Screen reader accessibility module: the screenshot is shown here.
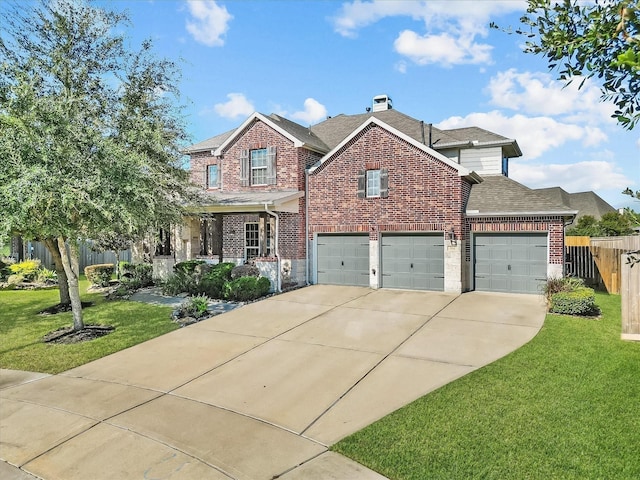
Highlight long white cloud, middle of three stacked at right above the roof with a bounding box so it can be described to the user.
[436,110,607,159]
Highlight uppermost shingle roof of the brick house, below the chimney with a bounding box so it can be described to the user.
[187,109,522,157]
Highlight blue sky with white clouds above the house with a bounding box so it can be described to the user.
[111,0,640,211]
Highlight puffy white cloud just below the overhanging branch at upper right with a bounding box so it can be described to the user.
[486,69,615,124]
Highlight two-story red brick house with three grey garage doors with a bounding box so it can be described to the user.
[157,96,575,292]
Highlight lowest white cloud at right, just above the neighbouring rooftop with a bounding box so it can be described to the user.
[509,160,629,193]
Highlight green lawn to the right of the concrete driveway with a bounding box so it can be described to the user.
[333,293,640,480]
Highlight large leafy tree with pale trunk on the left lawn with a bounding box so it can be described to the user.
[0,0,193,330]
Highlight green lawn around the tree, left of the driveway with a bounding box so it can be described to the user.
[0,280,178,373]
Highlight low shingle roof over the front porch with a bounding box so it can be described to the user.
[190,190,304,213]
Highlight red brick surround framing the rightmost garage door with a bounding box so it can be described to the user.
[465,216,564,265]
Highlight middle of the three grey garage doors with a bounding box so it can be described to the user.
[381,234,444,290]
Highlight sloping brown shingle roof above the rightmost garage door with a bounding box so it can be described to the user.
[466,175,577,217]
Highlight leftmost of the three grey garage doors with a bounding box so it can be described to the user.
[318,235,369,287]
